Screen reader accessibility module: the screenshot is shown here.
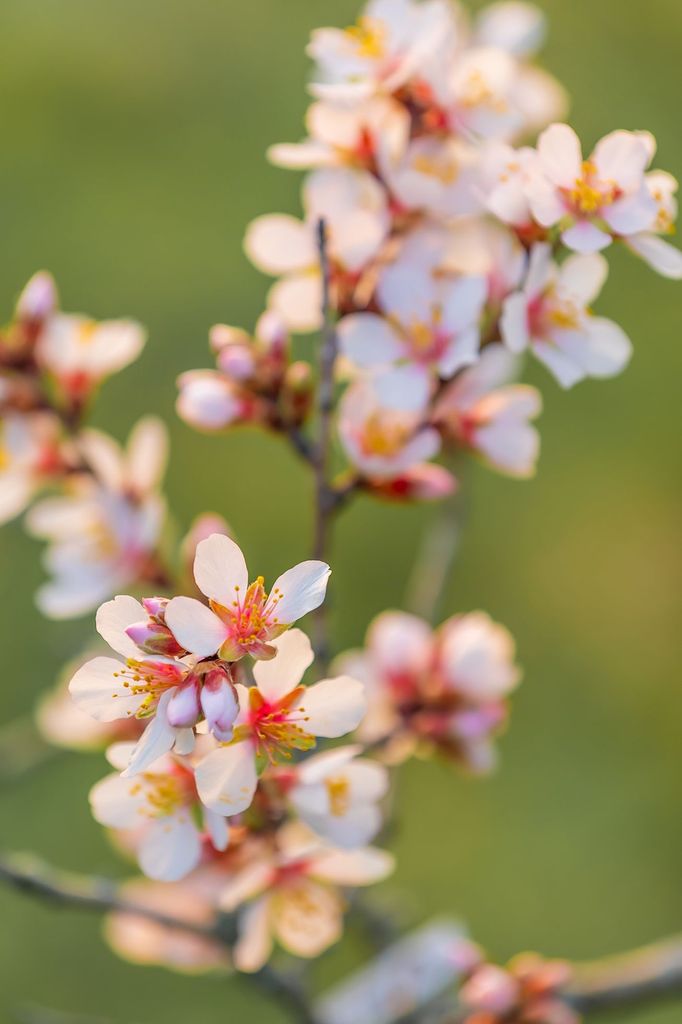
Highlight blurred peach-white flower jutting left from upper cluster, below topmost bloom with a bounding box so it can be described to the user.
[268,96,410,171]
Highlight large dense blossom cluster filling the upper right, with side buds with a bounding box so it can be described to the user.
[178,0,682,500]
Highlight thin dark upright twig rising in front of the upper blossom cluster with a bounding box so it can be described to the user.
[312,219,338,673]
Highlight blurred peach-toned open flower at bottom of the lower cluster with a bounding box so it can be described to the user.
[215,824,394,972]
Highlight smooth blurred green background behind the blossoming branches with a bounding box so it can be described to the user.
[0,0,682,1024]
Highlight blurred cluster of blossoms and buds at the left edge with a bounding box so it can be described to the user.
[0,272,173,618]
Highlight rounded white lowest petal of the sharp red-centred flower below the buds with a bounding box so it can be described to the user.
[195,740,258,817]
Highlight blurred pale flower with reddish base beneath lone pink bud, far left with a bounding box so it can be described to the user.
[36,313,146,402]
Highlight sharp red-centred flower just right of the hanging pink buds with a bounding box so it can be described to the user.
[191,630,366,816]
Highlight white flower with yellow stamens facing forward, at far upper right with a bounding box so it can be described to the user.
[527,124,656,254]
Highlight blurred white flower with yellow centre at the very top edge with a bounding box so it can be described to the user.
[307,0,456,103]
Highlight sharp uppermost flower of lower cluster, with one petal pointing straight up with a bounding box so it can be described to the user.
[161,534,331,662]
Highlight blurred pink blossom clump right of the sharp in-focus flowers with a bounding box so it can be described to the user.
[335,611,519,772]
